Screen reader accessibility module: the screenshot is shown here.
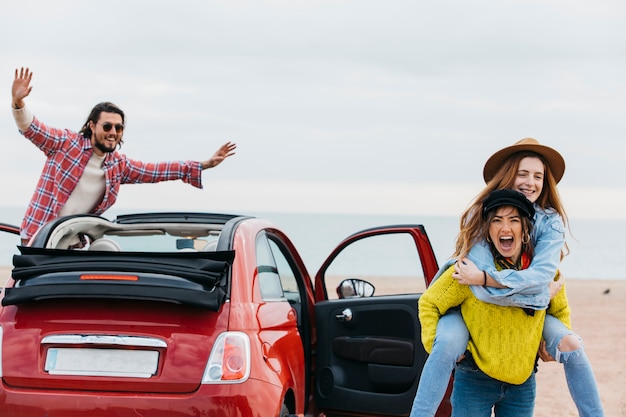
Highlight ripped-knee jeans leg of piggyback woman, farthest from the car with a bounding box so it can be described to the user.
[544,315,604,417]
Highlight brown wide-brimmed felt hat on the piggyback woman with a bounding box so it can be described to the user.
[483,138,565,183]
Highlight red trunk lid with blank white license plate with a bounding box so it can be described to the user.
[2,299,228,393]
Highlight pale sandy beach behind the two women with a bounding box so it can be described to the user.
[0,267,626,417]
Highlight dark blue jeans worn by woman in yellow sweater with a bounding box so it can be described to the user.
[452,361,536,417]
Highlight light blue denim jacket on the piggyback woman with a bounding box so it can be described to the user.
[435,206,565,310]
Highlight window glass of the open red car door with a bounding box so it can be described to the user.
[324,233,426,299]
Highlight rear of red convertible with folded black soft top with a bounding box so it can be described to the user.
[0,213,282,417]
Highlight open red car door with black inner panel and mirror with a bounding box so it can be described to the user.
[315,225,449,417]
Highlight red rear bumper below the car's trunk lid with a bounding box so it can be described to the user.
[0,379,283,417]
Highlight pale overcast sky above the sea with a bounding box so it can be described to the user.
[0,0,626,221]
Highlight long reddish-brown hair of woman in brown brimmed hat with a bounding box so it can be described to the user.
[453,151,569,258]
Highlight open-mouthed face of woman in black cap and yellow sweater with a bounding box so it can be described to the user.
[489,206,523,262]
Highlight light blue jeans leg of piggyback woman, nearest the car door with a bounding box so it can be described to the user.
[410,308,469,417]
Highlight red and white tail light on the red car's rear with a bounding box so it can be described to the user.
[202,332,250,384]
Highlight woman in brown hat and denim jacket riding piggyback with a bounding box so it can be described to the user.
[411,138,604,417]
